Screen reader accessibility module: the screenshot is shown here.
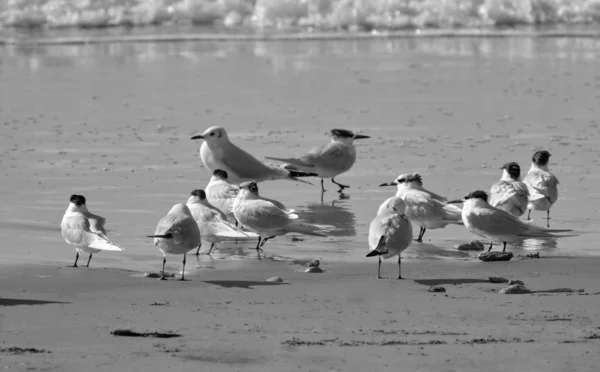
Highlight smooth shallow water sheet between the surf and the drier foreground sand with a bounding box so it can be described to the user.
[0,33,600,270]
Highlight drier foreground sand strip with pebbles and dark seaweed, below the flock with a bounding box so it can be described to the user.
[0,257,600,372]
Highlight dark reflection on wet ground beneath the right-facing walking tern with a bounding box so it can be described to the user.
[296,200,356,236]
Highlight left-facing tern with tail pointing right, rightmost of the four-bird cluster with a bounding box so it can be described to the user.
[233,182,333,259]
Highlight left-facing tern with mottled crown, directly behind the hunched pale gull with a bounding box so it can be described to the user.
[379,173,462,243]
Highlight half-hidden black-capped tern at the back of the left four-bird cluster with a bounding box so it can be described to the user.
[205,169,294,225]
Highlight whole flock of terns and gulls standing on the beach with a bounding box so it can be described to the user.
[61,126,572,280]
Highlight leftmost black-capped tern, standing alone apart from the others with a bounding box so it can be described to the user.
[60,194,124,267]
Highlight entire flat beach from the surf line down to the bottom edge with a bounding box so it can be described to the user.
[0,38,600,371]
